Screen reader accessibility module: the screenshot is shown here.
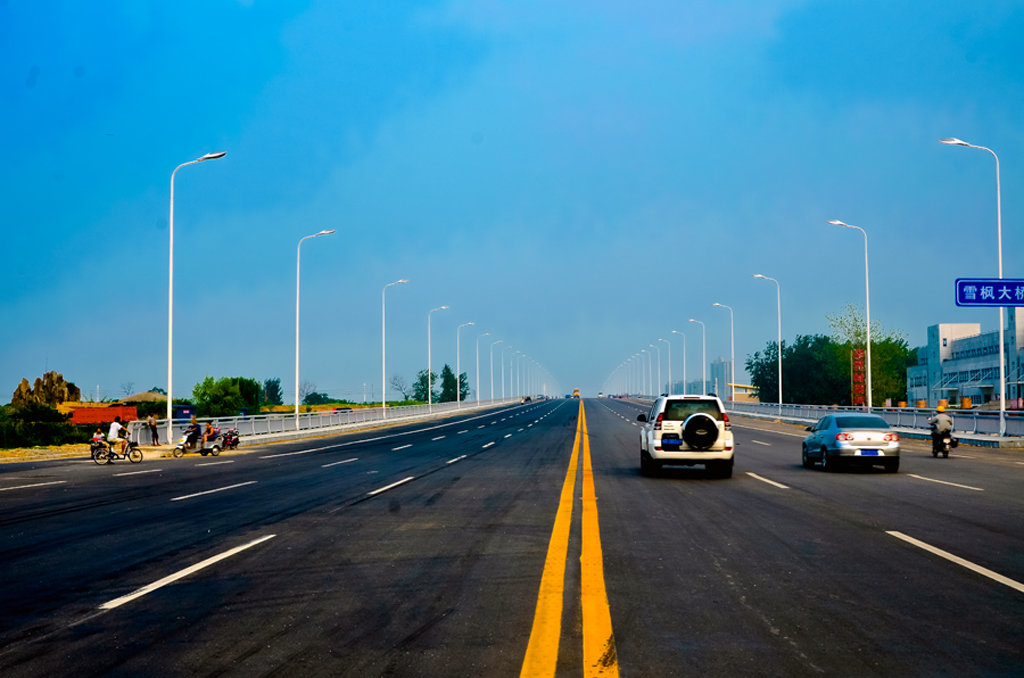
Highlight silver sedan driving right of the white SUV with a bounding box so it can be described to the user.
[803,412,899,473]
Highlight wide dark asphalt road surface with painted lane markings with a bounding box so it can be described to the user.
[0,399,1024,677]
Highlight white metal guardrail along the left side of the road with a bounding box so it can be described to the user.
[128,397,519,444]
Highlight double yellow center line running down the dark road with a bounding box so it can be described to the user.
[519,399,618,678]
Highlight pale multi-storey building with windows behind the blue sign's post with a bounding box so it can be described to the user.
[906,307,1024,408]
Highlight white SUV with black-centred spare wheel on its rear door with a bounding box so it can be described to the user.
[637,395,733,478]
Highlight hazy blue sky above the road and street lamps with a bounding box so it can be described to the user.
[0,0,1024,401]
